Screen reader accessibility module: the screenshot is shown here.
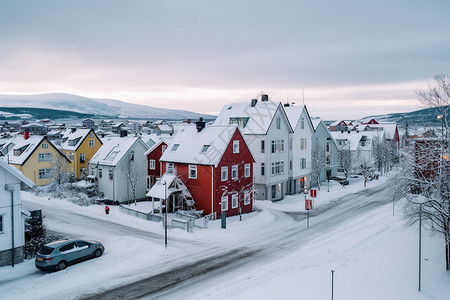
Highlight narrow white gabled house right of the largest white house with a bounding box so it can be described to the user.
[284,103,314,194]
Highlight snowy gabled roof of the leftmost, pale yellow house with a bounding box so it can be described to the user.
[3,135,70,165]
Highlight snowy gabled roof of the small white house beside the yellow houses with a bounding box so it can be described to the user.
[89,137,148,166]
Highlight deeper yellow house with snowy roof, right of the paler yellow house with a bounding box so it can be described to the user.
[61,128,103,179]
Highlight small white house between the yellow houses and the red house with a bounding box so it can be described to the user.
[88,137,149,202]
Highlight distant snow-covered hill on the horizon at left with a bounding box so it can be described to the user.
[0,93,215,120]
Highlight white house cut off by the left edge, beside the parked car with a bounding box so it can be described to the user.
[0,159,34,266]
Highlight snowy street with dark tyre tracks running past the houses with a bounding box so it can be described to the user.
[0,179,388,299]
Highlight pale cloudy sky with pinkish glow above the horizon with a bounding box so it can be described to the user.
[0,0,450,119]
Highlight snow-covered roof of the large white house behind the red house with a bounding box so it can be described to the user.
[214,101,281,134]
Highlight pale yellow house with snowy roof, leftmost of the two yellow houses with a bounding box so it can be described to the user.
[4,136,70,186]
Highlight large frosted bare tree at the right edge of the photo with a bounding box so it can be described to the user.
[394,75,450,270]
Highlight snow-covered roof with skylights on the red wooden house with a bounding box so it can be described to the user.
[161,124,239,166]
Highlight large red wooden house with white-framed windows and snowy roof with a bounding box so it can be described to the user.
[156,122,254,219]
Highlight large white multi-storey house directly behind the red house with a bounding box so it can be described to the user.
[214,94,292,200]
